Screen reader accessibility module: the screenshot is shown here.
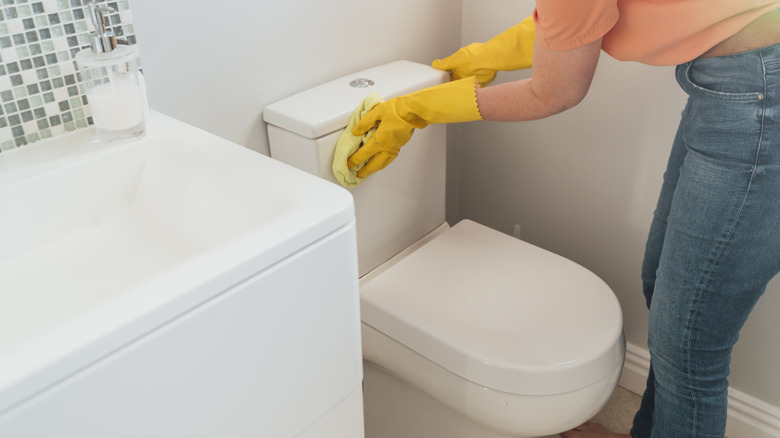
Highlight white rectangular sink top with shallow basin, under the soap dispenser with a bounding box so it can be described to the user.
[0,113,359,436]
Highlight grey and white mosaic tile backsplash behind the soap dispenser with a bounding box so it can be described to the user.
[0,0,135,153]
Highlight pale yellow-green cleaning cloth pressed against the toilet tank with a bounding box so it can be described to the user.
[332,93,384,188]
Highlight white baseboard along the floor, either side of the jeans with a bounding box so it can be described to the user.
[620,344,780,438]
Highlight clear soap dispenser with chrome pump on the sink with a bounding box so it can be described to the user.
[76,3,146,141]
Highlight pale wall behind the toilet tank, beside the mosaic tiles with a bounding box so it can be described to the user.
[130,0,461,154]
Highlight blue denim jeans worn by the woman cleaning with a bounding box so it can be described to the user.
[631,44,780,438]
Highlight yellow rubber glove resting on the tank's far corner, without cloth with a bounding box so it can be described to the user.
[432,16,536,87]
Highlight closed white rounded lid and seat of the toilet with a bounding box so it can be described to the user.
[360,221,625,395]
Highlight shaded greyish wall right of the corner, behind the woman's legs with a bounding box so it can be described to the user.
[458,0,780,406]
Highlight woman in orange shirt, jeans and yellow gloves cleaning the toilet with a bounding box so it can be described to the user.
[348,0,780,438]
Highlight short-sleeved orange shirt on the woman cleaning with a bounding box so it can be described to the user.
[534,0,780,65]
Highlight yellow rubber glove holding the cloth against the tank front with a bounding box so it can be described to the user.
[347,77,482,178]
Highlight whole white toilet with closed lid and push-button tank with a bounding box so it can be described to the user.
[264,61,625,438]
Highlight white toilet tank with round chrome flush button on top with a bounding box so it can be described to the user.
[263,61,449,276]
